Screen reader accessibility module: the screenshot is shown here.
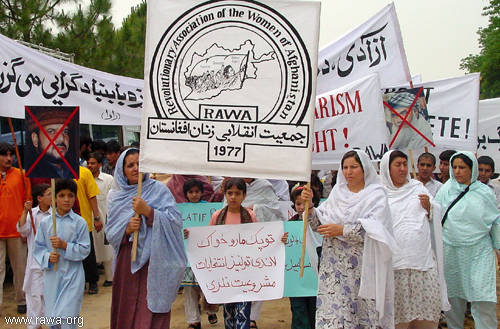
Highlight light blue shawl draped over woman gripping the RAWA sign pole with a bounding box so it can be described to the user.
[106,148,186,313]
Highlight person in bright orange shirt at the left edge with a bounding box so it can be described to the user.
[0,142,31,314]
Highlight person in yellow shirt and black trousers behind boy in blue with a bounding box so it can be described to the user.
[75,166,103,295]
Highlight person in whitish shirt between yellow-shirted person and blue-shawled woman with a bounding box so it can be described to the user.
[87,152,113,287]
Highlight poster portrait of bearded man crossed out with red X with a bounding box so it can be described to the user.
[26,108,79,178]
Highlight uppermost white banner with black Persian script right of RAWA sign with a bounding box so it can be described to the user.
[317,3,411,94]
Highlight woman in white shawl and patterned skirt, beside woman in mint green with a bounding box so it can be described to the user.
[380,150,449,329]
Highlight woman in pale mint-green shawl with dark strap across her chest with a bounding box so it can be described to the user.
[435,152,500,329]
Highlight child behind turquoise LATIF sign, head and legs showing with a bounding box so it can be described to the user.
[182,178,218,329]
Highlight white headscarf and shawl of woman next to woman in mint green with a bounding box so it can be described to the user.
[380,150,450,311]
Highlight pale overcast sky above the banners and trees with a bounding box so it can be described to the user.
[111,0,488,82]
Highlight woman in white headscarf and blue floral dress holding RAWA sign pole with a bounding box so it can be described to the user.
[301,150,396,329]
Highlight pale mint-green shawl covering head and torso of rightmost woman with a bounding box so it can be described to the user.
[435,151,500,249]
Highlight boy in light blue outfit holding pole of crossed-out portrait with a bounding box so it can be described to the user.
[33,179,90,328]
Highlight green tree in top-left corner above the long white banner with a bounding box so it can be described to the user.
[0,0,80,44]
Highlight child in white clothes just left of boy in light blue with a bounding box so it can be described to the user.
[17,184,52,329]
